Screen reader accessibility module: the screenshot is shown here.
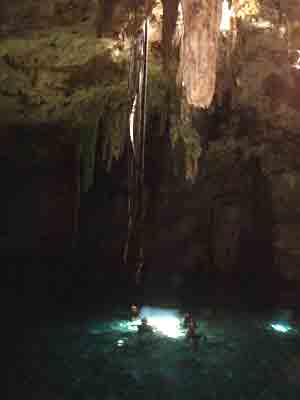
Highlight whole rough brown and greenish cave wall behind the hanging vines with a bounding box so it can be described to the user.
[0,2,300,304]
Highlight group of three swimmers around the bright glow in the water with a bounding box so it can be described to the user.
[131,304,199,351]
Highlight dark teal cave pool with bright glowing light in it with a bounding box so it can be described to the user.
[9,307,300,400]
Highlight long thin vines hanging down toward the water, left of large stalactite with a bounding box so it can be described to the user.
[123,10,148,290]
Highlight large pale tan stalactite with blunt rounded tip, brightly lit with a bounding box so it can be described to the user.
[182,0,222,108]
